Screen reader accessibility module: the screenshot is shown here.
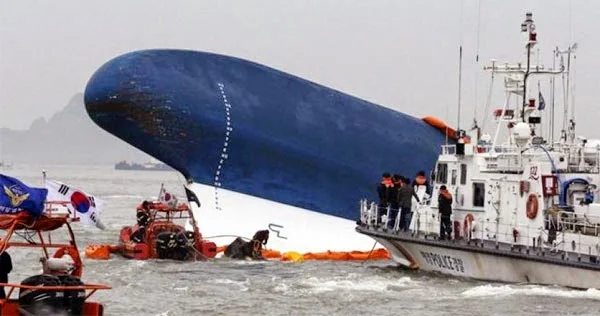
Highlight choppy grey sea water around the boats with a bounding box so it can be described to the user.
[0,165,600,316]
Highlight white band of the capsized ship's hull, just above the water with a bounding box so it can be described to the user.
[187,183,401,260]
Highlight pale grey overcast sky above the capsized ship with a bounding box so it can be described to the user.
[0,0,600,138]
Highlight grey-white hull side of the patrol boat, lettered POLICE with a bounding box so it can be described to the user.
[357,227,600,289]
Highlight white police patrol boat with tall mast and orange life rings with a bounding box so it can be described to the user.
[356,13,600,288]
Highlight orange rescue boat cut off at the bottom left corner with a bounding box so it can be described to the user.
[0,202,111,316]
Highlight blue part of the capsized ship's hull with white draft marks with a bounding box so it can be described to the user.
[85,50,444,219]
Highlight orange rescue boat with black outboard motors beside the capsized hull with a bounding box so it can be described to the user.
[116,201,217,261]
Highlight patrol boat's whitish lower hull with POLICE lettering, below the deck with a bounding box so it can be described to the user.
[372,236,600,289]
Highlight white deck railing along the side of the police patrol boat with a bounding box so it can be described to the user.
[360,200,600,263]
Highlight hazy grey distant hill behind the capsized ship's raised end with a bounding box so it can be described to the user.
[0,93,155,165]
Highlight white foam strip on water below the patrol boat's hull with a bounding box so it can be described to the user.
[462,284,600,300]
